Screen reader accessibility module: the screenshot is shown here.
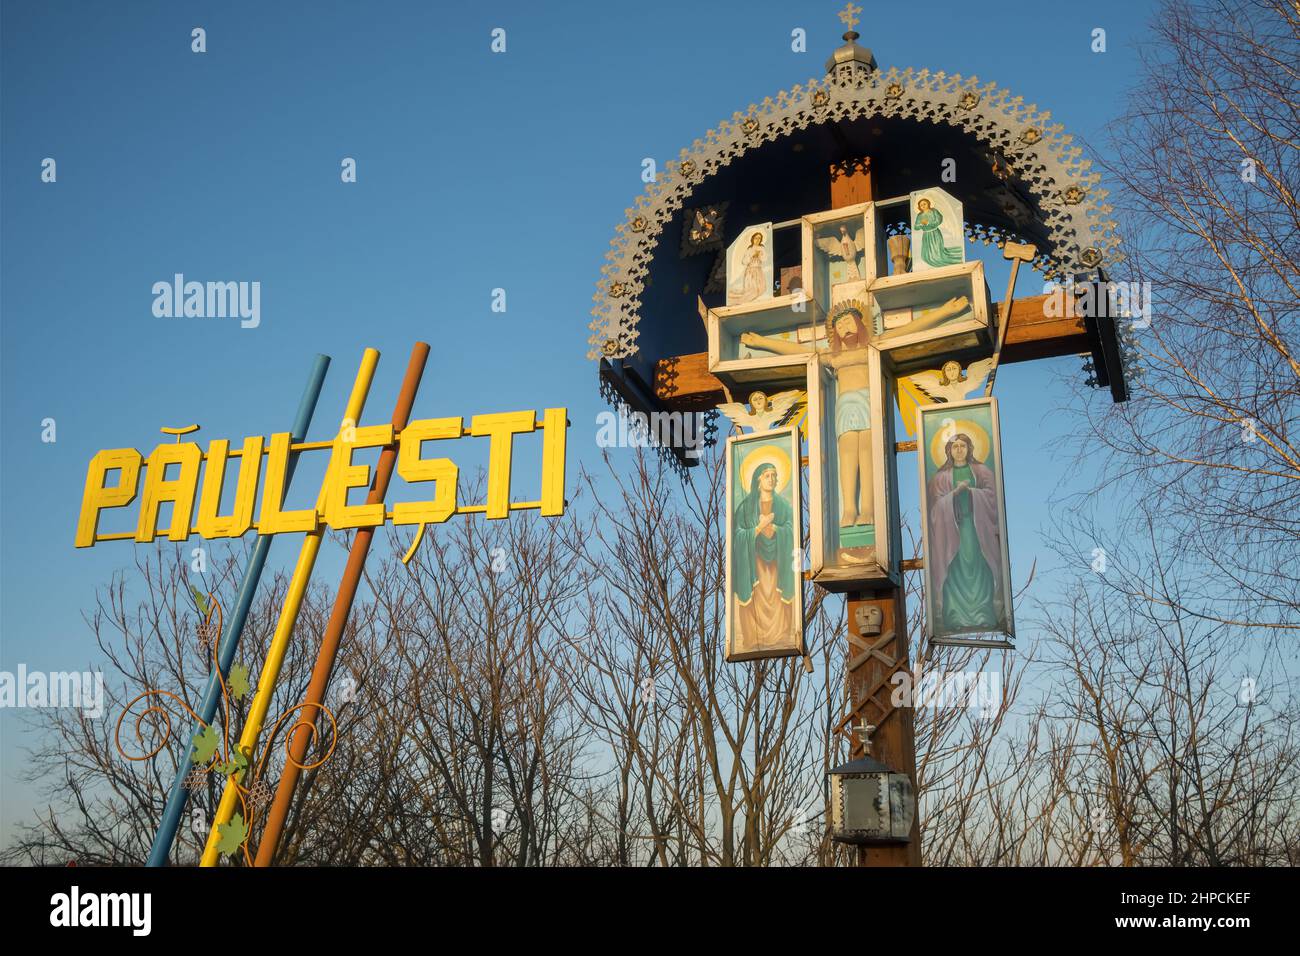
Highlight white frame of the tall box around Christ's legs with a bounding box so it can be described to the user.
[807,347,901,592]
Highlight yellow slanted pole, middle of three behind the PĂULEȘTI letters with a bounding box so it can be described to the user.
[199,349,380,866]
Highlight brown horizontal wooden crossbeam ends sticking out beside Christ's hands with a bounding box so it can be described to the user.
[654,295,1092,411]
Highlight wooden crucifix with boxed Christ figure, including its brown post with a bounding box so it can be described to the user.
[691,160,1089,864]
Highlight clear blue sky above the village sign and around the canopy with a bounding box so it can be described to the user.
[0,0,1152,842]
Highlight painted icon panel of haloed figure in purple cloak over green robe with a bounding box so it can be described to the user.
[917,398,1014,644]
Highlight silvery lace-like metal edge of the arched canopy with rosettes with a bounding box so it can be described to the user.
[588,60,1122,359]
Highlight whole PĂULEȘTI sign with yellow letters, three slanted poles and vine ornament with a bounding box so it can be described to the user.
[83,342,569,866]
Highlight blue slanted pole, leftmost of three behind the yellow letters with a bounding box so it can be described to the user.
[148,355,329,866]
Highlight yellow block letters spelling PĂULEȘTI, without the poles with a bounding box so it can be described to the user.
[77,408,568,558]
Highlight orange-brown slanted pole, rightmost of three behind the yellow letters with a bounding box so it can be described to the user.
[254,342,429,866]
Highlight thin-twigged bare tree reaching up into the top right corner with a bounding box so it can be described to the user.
[1079,0,1300,637]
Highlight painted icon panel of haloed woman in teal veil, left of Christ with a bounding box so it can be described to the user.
[727,427,803,661]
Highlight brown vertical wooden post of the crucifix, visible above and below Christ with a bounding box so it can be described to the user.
[831,156,920,866]
